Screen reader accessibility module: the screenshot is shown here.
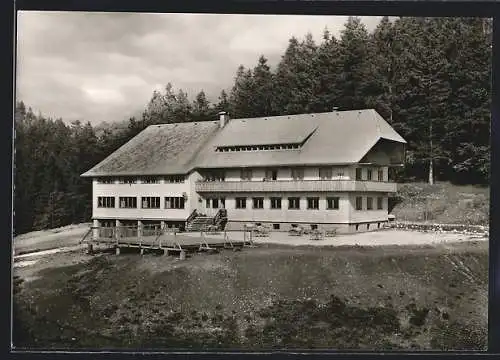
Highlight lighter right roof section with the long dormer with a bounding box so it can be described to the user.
[194,109,406,168]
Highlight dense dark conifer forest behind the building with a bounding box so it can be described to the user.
[14,17,492,234]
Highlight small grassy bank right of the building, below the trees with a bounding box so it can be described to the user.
[392,183,490,225]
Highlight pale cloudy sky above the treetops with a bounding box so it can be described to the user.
[16,11,380,124]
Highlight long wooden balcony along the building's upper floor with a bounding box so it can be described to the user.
[195,180,397,193]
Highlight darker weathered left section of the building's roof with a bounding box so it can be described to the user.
[82,121,219,177]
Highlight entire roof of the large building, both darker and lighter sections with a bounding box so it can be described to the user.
[82,109,406,176]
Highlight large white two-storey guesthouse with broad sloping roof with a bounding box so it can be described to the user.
[82,109,406,232]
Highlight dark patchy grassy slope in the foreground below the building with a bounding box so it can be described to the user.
[14,243,488,349]
